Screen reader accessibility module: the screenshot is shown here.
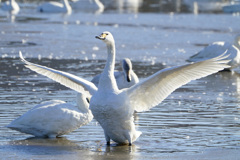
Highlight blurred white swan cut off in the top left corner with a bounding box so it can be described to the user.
[0,0,20,14]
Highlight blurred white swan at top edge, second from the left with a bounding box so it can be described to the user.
[37,0,72,13]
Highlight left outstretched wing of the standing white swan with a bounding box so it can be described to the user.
[19,51,97,95]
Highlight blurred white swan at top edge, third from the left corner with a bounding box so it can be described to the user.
[70,0,104,13]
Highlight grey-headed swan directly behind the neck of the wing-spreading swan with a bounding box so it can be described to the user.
[91,58,139,89]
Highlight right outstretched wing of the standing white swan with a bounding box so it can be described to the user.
[126,54,229,112]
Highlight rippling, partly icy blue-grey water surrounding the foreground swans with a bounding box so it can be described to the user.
[0,0,240,159]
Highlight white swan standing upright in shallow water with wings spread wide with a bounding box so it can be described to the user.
[17,32,229,145]
